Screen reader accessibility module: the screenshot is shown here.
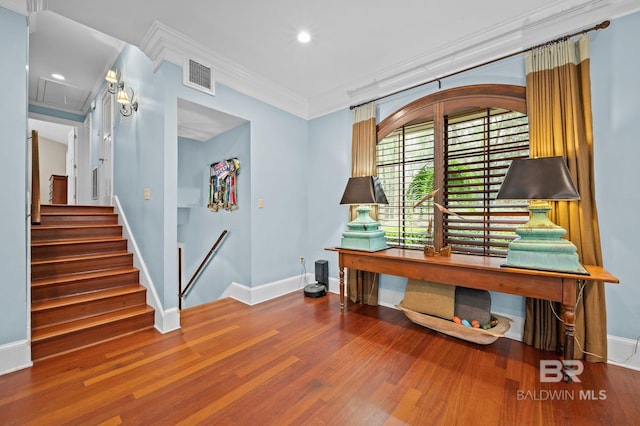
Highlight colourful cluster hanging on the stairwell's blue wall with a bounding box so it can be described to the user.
[207,158,240,212]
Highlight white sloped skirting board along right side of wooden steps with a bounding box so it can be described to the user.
[113,195,180,334]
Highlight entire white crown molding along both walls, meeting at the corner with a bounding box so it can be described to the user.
[15,0,640,119]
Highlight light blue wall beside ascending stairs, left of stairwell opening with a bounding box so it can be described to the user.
[108,45,172,309]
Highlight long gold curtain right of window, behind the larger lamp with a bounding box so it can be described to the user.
[524,35,607,362]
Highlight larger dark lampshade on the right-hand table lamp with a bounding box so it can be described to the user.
[496,157,580,200]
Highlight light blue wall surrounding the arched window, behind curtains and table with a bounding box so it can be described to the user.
[308,13,640,339]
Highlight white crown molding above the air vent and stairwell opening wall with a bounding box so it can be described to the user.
[139,21,309,119]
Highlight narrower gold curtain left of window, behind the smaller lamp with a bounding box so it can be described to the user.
[347,102,378,305]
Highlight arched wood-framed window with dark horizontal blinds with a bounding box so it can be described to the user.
[377,85,529,256]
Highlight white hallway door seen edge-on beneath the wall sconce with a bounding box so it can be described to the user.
[98,92,113,206]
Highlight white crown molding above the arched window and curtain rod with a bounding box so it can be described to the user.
[320,0,640,117]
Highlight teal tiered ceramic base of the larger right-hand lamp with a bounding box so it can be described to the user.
[502,202,589,275]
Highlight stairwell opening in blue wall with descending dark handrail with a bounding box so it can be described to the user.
[177,98,251,307]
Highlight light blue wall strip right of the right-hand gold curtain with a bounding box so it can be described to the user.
[591,13,640,339]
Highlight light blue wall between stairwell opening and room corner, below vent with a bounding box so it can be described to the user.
[169,71,309,287]
